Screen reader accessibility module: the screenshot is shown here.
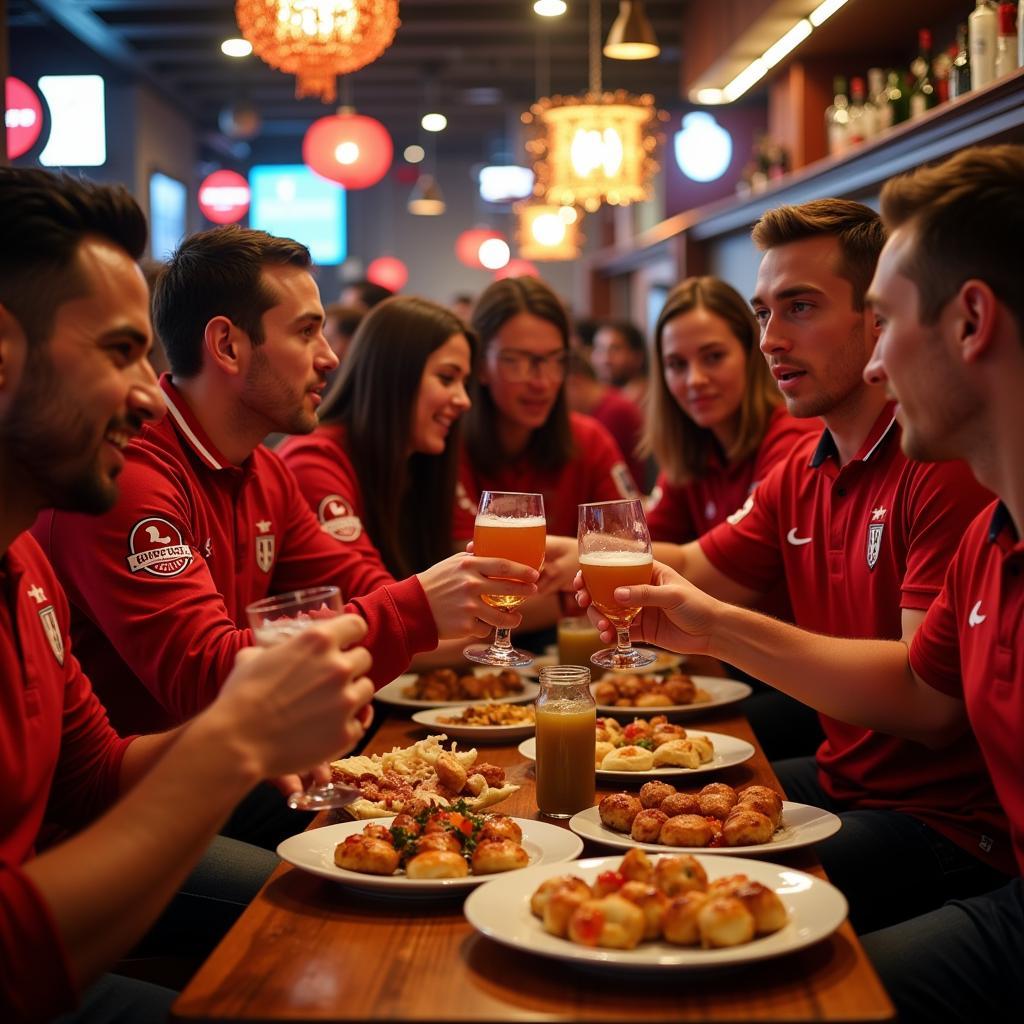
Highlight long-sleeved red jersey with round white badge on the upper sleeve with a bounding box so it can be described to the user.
[33,377,437,732]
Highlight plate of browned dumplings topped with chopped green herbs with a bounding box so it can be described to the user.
[278,805,583,898]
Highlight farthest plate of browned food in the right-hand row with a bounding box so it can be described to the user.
[590,671,752,718]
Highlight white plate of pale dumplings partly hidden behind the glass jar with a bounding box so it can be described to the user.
[518,719,754,782]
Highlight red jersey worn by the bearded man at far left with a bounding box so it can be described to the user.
[0,534,131,1020]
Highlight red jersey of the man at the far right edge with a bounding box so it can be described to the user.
[910,503,1024,872]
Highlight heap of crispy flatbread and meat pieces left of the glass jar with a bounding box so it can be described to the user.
[331,733,519,818]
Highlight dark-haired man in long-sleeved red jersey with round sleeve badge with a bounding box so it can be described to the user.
[34,225,538,849]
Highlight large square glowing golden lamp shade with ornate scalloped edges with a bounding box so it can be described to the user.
[522,90,668,212]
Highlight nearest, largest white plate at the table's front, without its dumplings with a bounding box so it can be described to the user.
[464,856,847,971]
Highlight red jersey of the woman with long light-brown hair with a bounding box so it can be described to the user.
[647,406,821,544]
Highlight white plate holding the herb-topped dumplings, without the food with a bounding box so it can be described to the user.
[278,816,583,898]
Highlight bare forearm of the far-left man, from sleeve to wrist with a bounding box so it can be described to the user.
[24,716,261,985]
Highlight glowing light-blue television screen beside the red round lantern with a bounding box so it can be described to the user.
[249,164,348,265]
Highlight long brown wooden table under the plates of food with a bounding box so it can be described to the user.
[174,692,893,1022]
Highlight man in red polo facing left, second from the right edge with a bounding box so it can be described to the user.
[581,200,1014,931]
